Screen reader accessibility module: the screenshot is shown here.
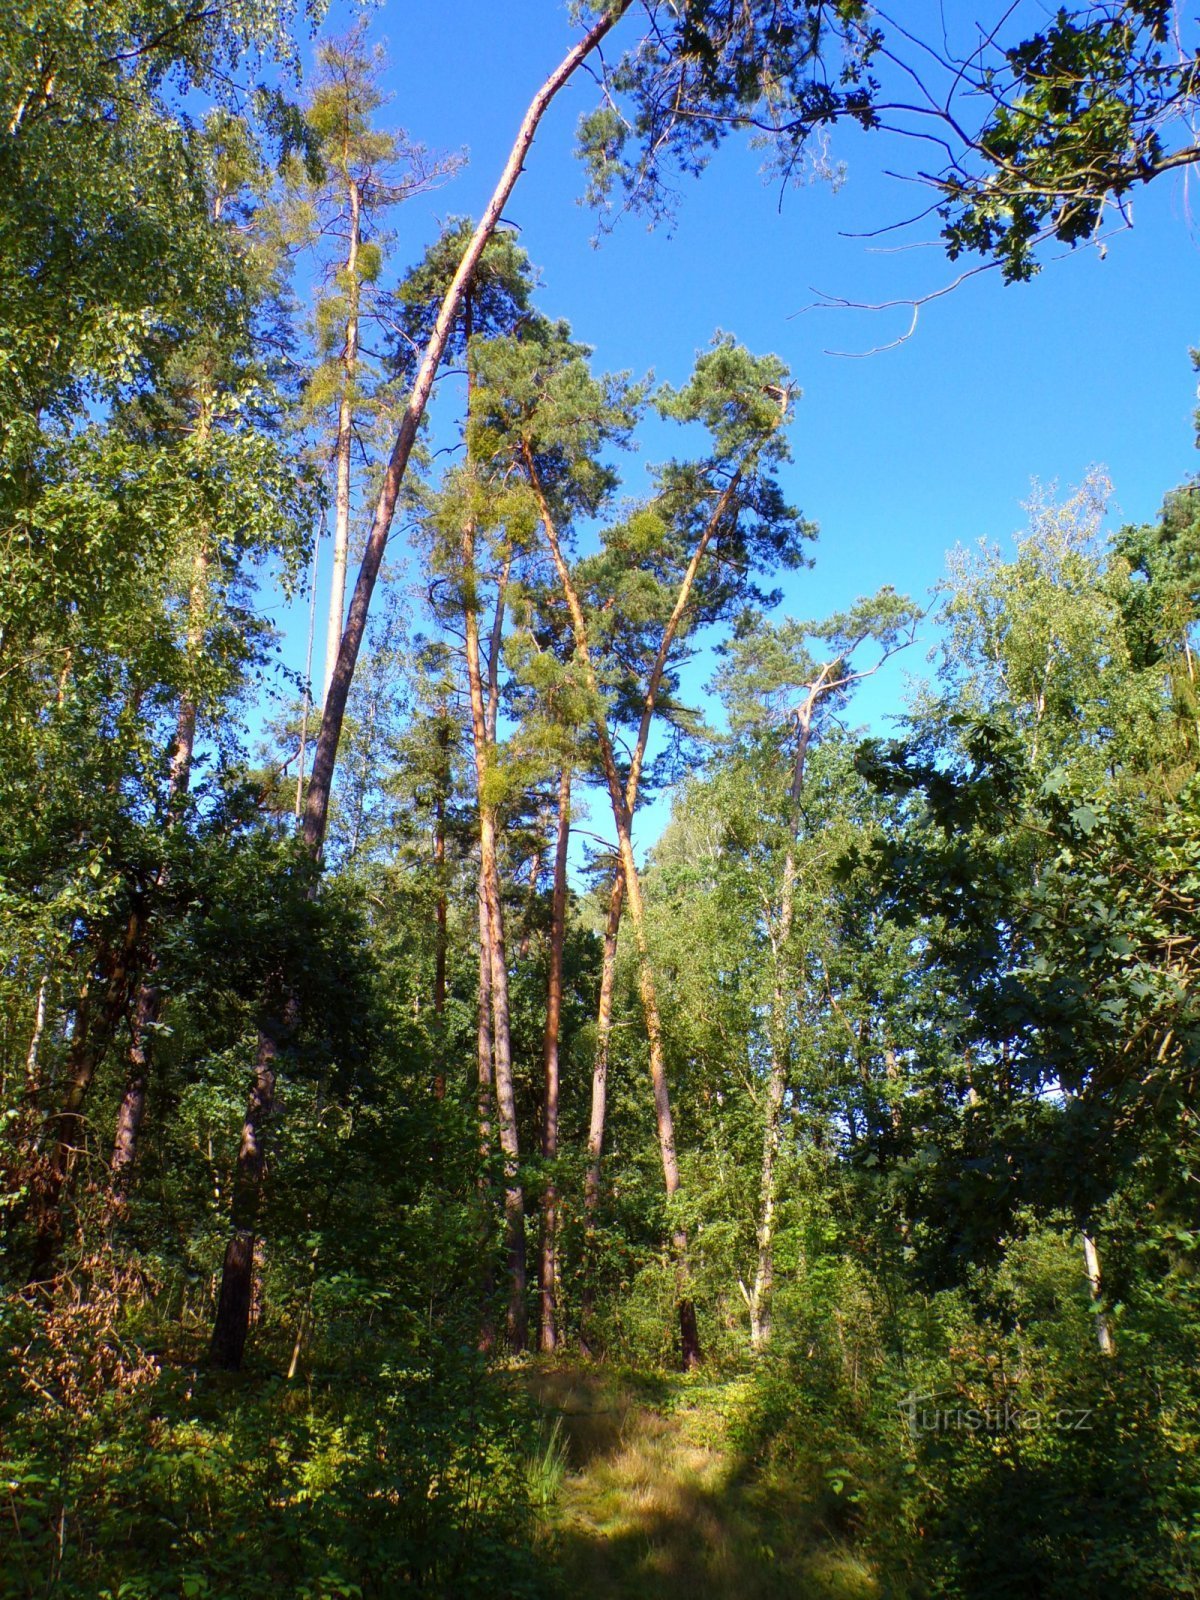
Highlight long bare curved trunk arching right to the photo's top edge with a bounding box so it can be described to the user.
[304,0,632,854]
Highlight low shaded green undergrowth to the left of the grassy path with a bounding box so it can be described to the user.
[0,1349,555,1600]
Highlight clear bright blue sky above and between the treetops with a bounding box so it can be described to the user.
[267,0,1200,846]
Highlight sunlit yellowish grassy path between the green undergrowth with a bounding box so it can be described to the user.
[525,1366,880,1600]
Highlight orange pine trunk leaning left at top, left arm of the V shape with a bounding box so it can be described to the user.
[526,458,701,1370]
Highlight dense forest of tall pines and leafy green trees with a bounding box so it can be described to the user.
[0,0,1200,1600]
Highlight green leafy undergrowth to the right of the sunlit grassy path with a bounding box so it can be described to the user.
[734,1234,1197,1597]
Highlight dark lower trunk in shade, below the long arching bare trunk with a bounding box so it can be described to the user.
[208,995,298,1373]
